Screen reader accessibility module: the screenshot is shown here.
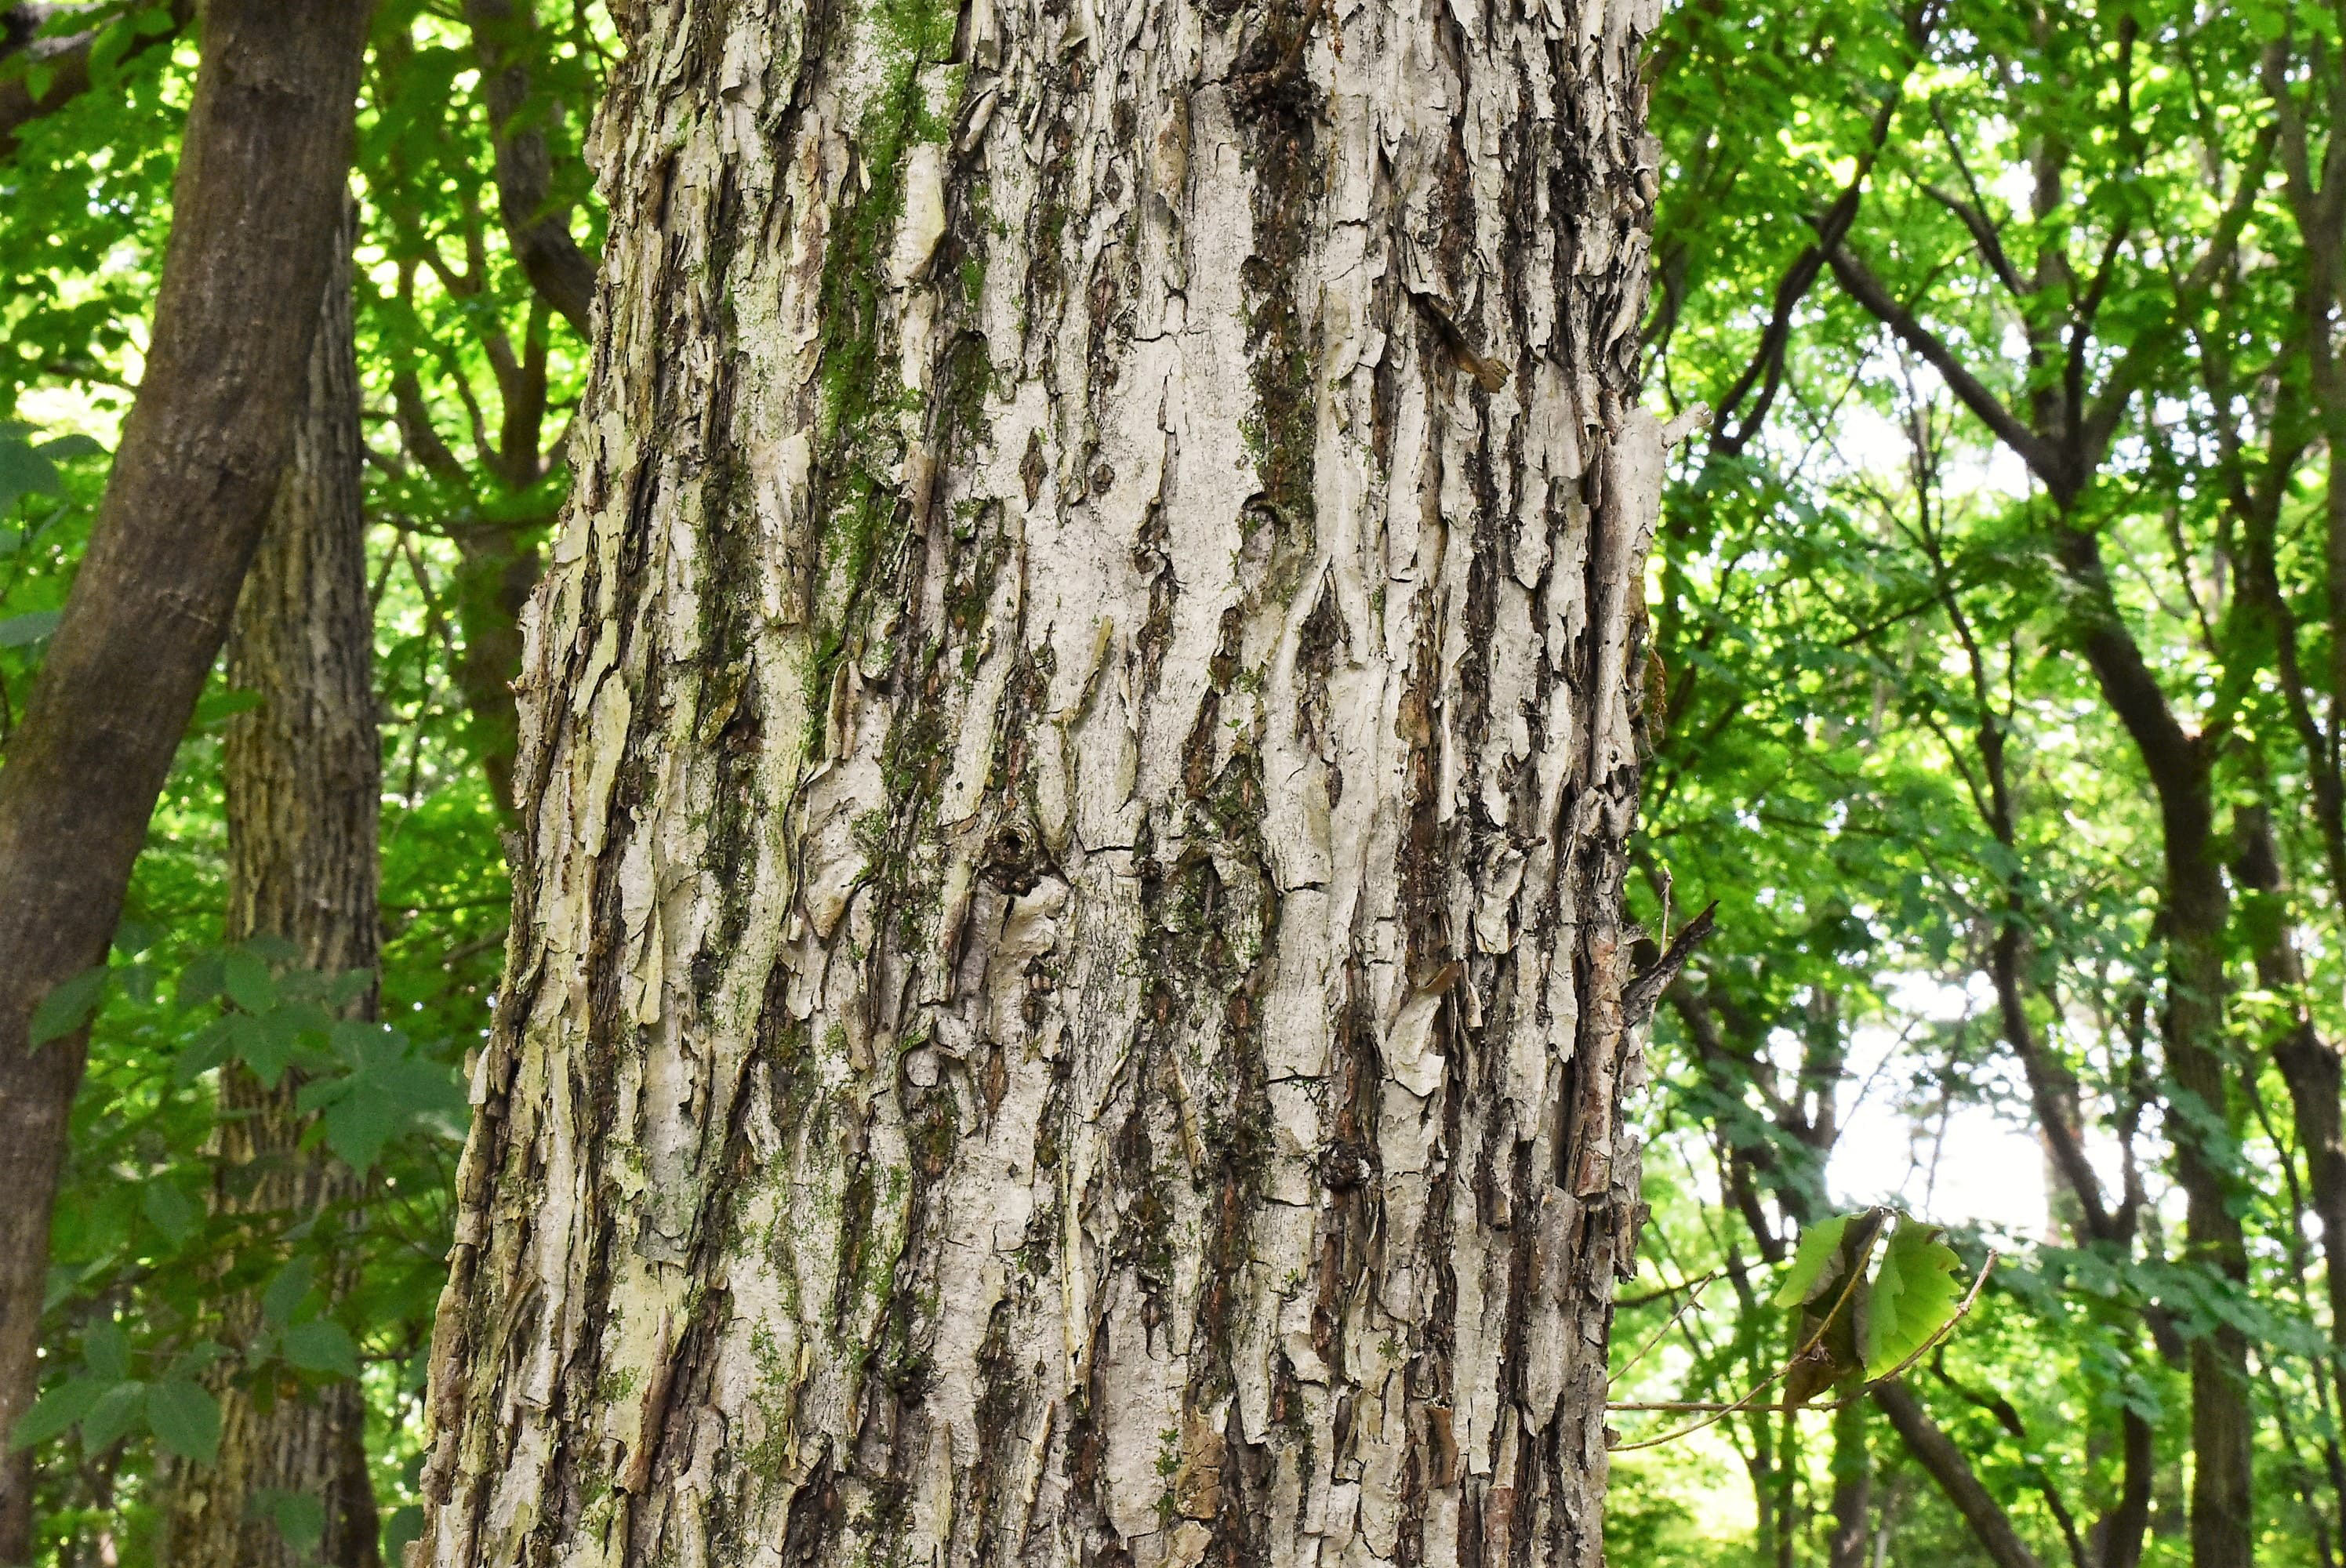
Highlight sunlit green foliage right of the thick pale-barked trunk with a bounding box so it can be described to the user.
[1614,0,2346,1563]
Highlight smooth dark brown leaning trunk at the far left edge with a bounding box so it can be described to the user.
[0,0,369,1563]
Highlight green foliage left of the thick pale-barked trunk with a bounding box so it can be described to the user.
[0,0,612,1566]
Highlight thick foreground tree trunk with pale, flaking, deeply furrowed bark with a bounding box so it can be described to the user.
[418,0,1663,1568]
